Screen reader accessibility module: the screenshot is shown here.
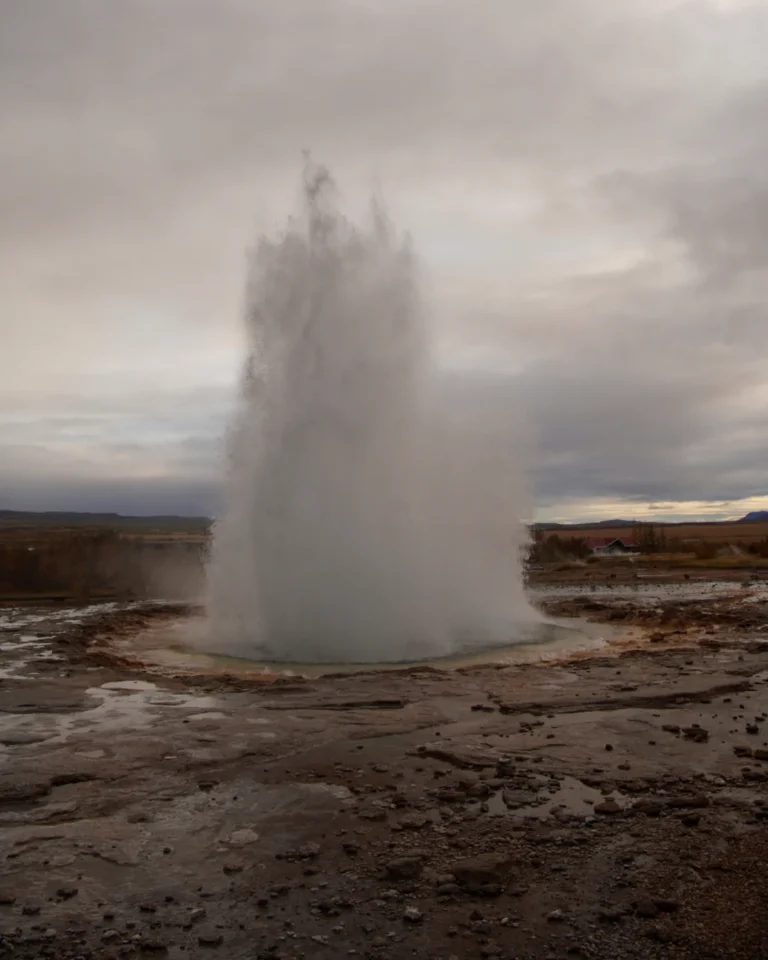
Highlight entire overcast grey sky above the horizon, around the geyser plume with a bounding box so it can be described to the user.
[0,0,768,519]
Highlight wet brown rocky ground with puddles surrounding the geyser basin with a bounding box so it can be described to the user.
[0,584,768,960]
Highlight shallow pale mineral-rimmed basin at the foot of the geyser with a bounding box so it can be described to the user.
[115,617,630,677]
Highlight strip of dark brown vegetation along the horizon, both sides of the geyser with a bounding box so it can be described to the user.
[0,515,768,602]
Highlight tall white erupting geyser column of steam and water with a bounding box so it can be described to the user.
[207,170,539,663]
